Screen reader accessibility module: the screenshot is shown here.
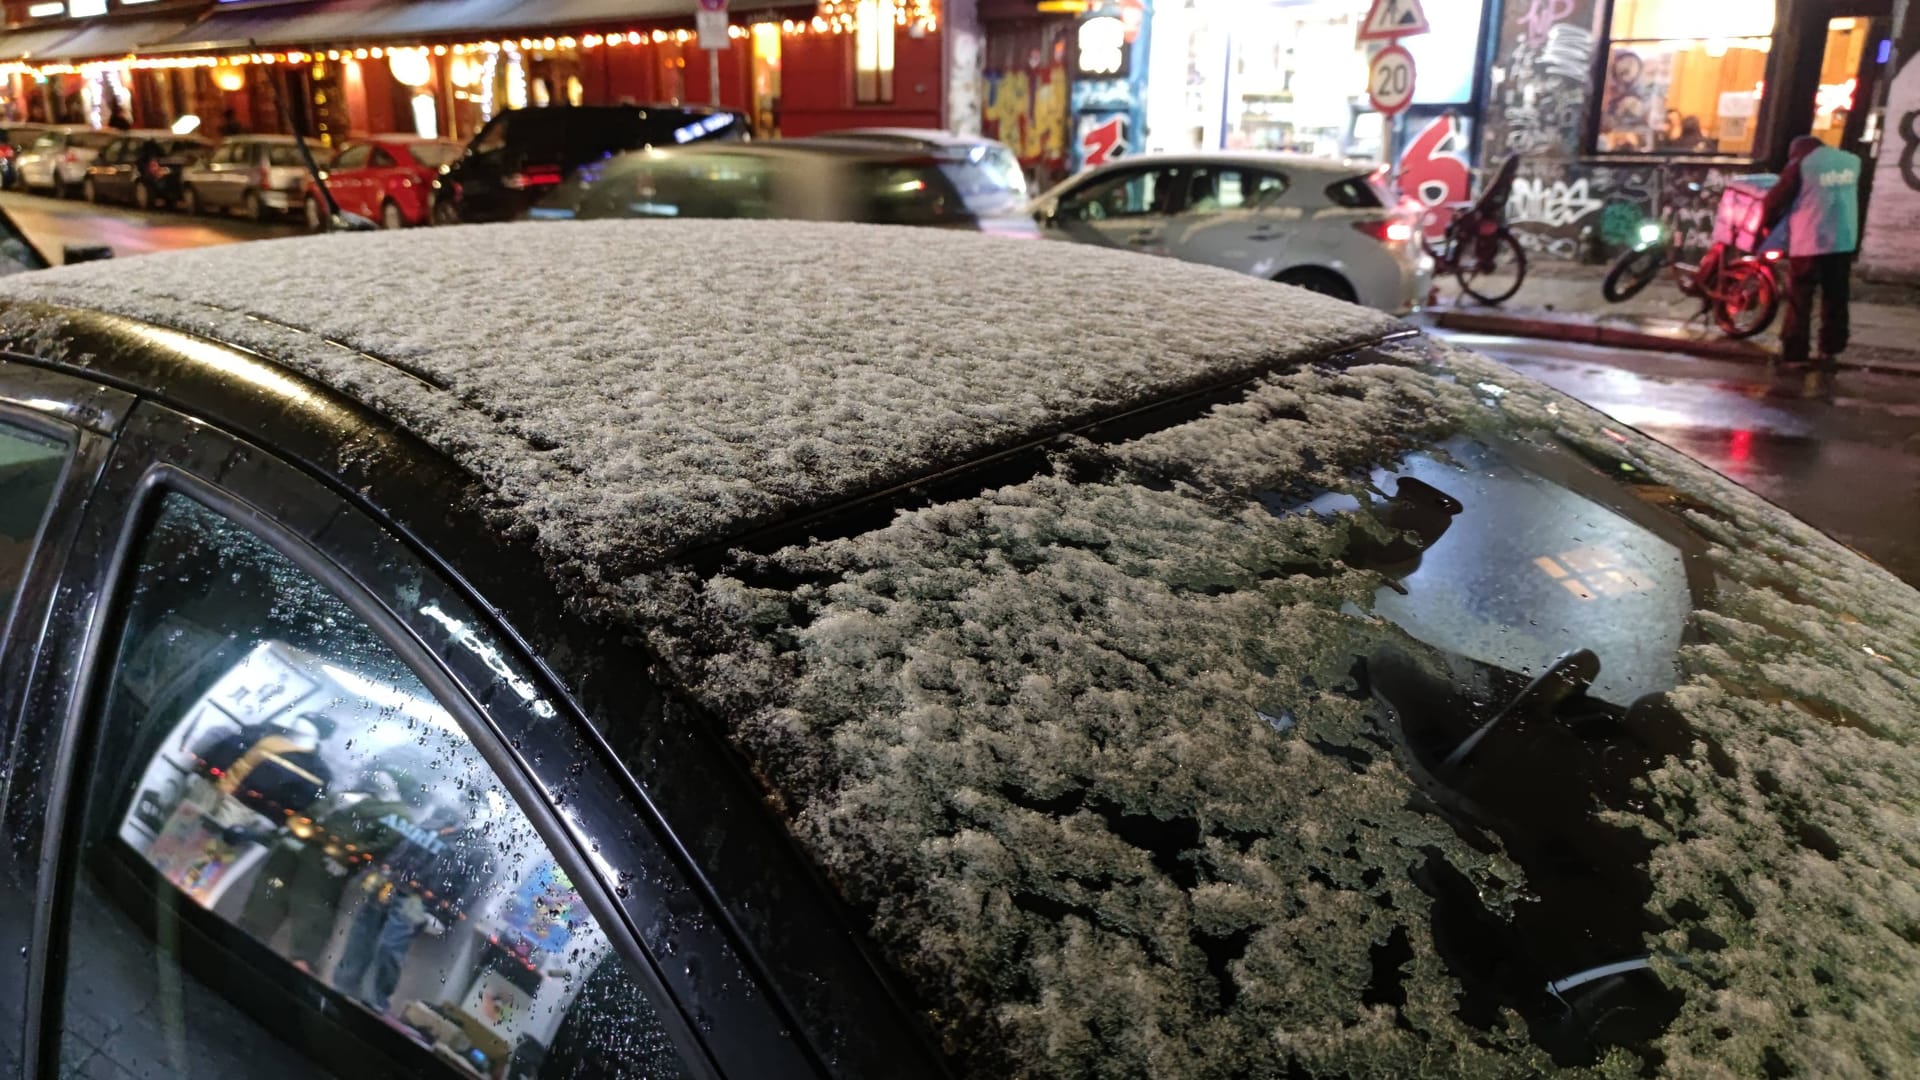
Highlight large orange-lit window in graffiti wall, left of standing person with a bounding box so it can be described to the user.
[1596,0,1774,156]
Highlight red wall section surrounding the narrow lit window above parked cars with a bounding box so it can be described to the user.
[780,29,943,136]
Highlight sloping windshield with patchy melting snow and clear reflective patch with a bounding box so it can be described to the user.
[662,338,1920,1076]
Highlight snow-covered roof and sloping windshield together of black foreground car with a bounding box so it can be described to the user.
[0,223,1920,1078]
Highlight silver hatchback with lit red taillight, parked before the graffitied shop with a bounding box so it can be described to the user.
[1031,152,1432,313]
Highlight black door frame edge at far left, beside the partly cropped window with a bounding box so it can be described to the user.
[0,352,134,1065]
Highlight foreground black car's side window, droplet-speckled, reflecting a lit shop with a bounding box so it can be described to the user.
[58,494,698,1080]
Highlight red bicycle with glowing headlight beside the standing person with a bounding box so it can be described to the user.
[1599,184,1788,340]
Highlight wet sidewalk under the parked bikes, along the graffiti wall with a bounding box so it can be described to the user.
[1415,261,1920,375]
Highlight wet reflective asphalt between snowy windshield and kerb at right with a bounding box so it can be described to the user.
[1446,334,1920,584]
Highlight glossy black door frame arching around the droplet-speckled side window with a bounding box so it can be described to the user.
[8,402,837,1076]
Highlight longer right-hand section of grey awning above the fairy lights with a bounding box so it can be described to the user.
[144,0,729,54]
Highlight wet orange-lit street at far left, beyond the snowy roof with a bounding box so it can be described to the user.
[0,184,300,263]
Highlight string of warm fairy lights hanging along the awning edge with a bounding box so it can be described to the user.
[0,0,939,77]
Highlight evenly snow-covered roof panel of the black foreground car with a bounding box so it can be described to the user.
[6,221,1402,565]
